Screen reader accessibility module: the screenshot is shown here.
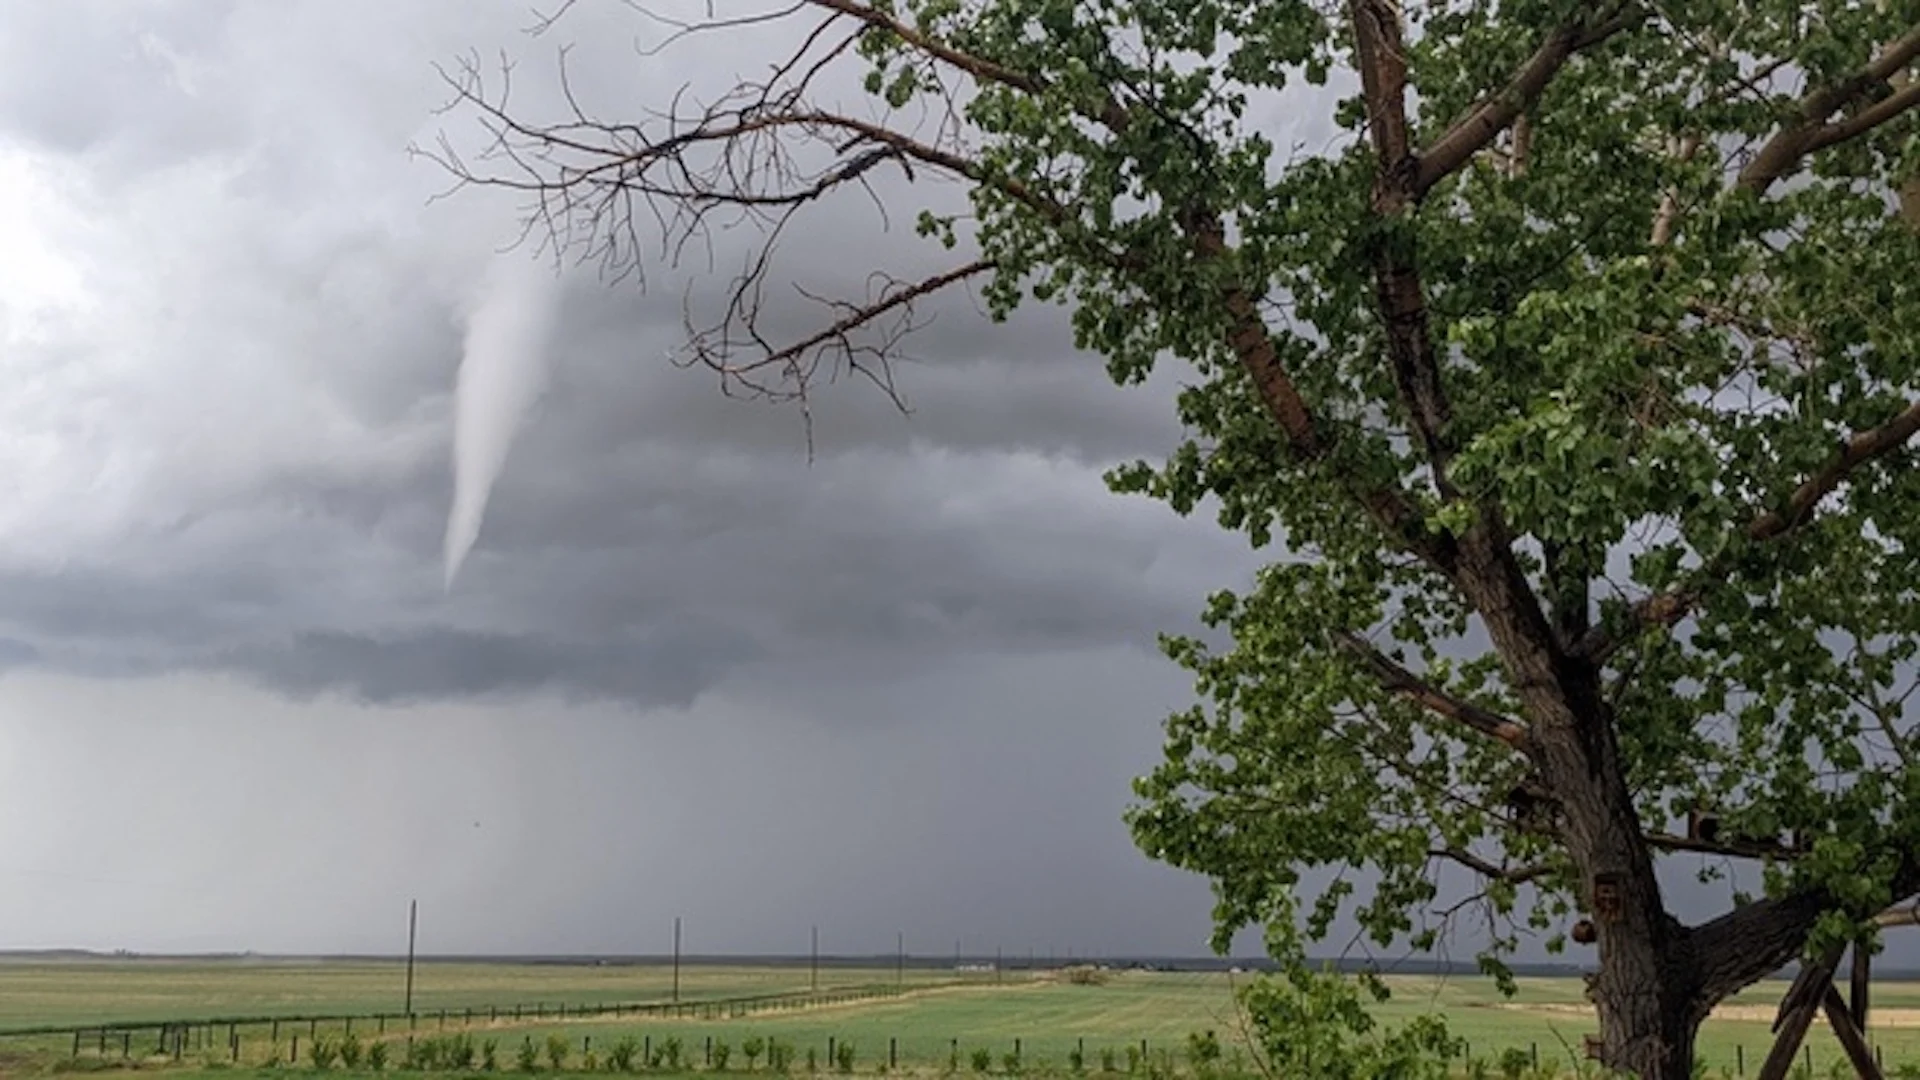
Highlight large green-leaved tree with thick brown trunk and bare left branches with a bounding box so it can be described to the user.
[444,0,1920,1078]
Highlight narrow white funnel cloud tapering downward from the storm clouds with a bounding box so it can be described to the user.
[444,256,559,590]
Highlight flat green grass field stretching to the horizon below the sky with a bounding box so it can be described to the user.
[0,961,1920,1080]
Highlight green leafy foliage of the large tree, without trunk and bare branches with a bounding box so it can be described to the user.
[866,0,1920,976]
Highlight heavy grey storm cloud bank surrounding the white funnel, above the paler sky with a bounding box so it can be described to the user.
[0,6,1246,705]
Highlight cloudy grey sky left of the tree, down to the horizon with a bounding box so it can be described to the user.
[0,0,1254,953]
